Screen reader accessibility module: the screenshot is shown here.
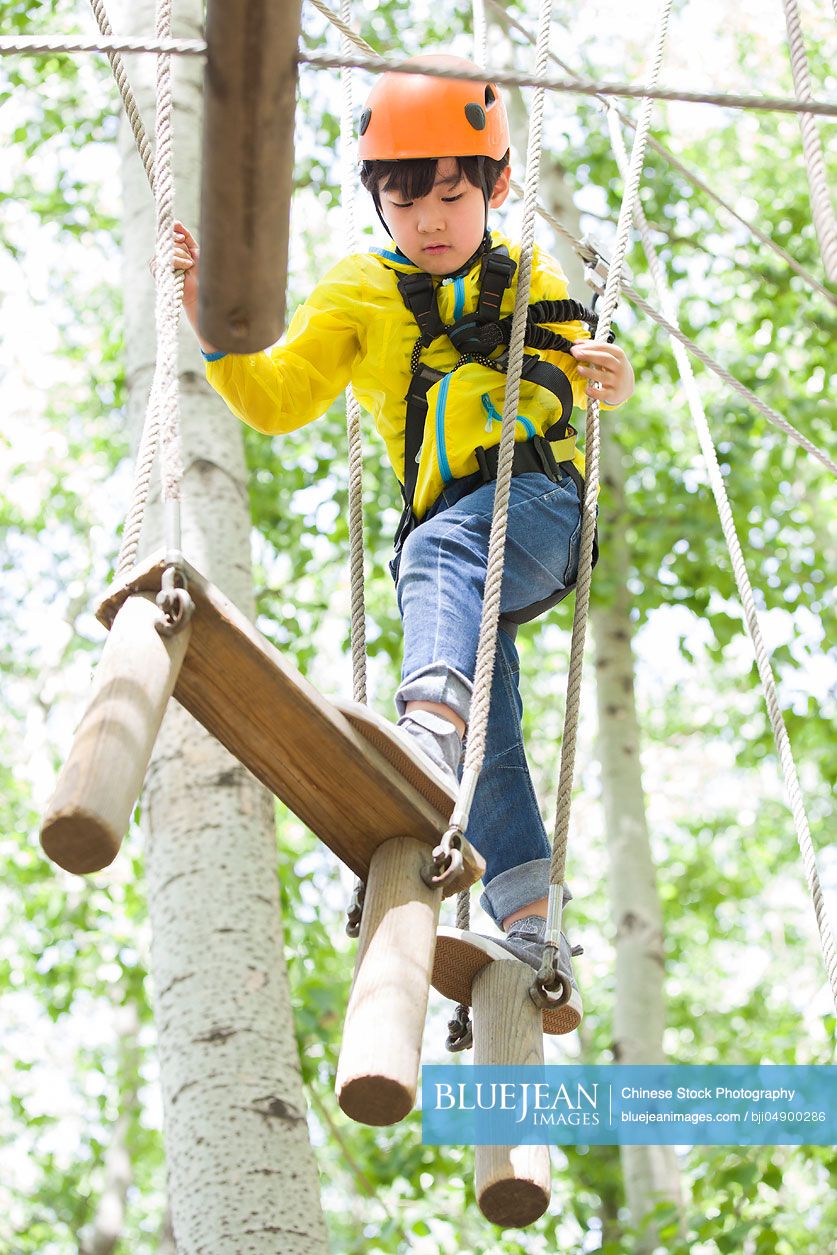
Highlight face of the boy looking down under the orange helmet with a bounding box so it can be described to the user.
[380,157,511,275]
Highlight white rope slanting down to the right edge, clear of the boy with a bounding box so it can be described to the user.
[609,110,837,1005]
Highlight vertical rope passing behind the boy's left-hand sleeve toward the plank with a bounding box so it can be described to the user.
[340,0,368,703]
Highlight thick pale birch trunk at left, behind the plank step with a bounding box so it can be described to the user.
[118,0,328,1255]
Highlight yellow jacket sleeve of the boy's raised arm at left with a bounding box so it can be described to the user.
[206,257,365,435]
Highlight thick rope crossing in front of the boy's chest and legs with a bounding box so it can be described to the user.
[450,0,552,929]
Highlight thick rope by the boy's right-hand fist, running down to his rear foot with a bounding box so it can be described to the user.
[550,0,673,893]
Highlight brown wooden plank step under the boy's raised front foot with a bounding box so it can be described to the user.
[97,555,484,896]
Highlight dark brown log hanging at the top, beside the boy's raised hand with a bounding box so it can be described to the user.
[198,0,300,353]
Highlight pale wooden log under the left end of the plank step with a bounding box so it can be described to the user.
[40,596,192,873]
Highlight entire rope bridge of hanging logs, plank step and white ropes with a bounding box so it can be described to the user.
[9,0,837,1225]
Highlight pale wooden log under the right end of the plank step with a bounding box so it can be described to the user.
[336,837,442,1124]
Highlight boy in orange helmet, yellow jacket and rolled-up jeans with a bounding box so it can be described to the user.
[176,55,634,1032]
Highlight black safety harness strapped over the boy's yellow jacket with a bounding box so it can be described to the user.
[390,245,602,625]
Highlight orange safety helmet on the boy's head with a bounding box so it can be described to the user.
[358,53,508,161]
